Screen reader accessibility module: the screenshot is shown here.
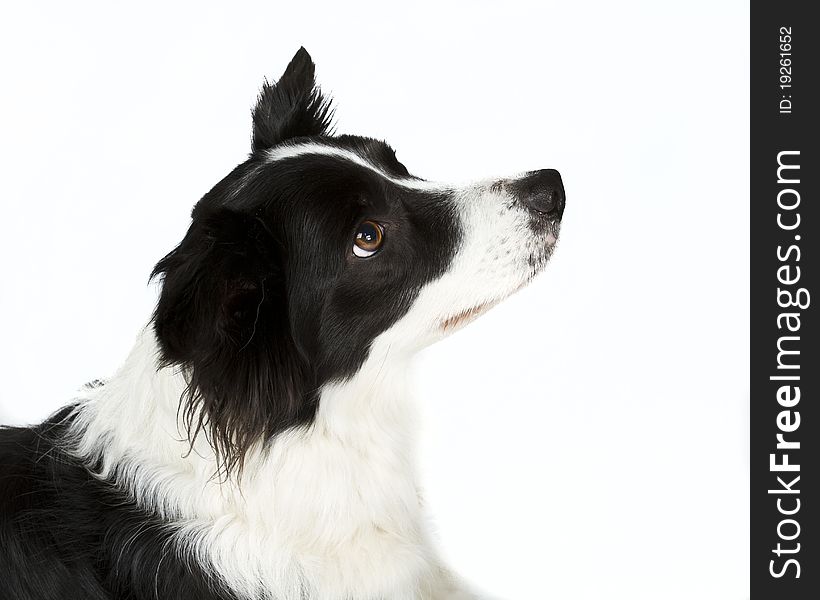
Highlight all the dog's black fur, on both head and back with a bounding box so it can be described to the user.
[0,49,461,600]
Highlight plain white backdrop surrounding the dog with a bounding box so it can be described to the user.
[0,0,749,600]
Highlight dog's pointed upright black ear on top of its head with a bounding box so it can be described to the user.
[252,48,332,152]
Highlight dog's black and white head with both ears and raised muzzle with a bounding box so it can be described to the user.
[154,49,564,465]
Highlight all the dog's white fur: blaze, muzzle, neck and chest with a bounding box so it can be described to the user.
[67,159,547,600]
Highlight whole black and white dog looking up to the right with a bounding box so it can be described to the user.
[0,49,564,600]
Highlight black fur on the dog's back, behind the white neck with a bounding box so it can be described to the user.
[0,408,235,600]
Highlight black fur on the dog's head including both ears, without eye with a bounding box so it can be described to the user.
[152,49,461,472]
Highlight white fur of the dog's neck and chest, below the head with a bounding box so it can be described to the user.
[67,328,468,600]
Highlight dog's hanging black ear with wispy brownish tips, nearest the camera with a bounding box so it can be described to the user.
[151,209,315,471]
